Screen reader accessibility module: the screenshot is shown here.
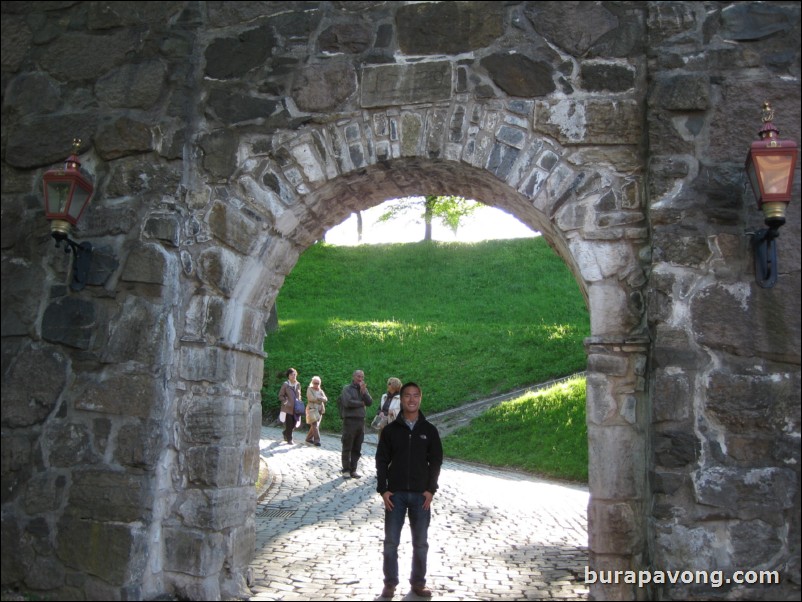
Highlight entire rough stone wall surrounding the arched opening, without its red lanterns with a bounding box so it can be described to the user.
[2,2,800,599]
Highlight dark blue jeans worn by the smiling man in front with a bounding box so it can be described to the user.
[384,491,432,587]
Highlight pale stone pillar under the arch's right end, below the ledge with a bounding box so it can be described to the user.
[585,337,649,600]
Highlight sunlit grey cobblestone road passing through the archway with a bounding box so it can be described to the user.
[251,427,588,600]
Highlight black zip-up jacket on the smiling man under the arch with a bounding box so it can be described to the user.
[376,412,443,494]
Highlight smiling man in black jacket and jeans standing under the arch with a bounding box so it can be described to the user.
[376,382,443,598]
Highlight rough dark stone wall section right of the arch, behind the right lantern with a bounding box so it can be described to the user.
[647,3,800,599]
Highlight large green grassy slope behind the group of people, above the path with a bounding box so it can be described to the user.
[262,237,589,480]
